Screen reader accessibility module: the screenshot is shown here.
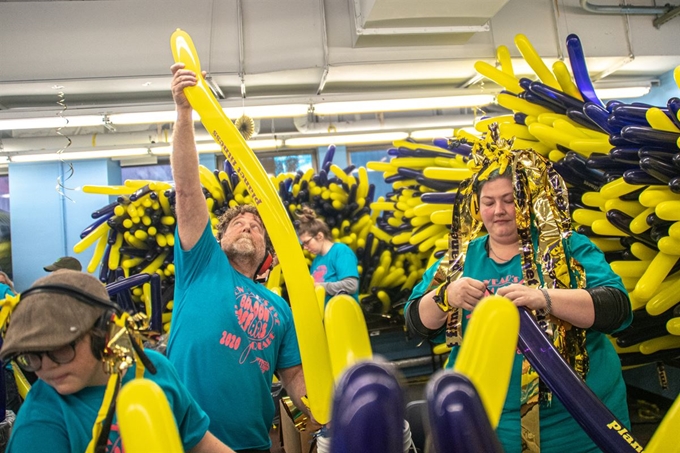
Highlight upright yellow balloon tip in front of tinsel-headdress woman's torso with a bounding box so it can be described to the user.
[453,295,519,428]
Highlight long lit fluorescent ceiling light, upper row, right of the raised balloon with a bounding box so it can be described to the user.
[314,94,494,115]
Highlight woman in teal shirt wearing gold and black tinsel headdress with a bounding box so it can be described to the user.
[405,125,632,453]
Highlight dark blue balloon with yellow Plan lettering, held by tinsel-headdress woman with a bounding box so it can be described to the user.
[518,308,642,453]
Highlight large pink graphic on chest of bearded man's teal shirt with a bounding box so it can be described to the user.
[234,286,281,372]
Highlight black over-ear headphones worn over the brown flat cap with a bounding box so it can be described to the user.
[21,283,122,360]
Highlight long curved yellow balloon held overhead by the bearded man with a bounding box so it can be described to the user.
[170,29,333,424]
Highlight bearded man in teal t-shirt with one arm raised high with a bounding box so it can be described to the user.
[167,63,307,452]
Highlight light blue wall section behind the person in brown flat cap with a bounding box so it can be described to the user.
[9,159,121,291]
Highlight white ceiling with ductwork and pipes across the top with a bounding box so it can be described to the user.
[0,0,680,152]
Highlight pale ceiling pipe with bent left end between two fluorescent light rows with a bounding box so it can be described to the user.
[293,115,475,134]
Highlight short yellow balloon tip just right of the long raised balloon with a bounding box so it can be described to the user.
[325,294,373,379]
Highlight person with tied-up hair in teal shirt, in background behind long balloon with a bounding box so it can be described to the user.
[295,206,359,303]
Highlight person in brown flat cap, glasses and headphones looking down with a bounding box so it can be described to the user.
[0,269,234,453]
